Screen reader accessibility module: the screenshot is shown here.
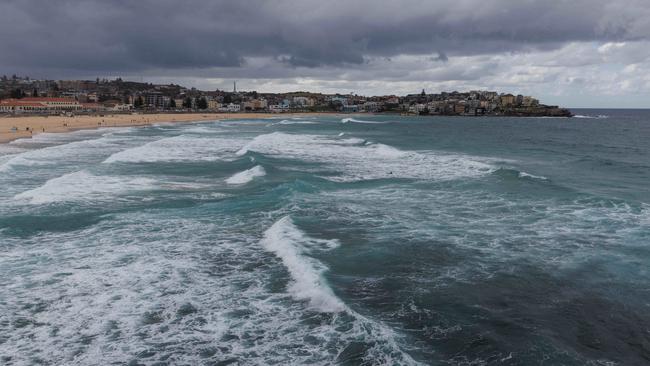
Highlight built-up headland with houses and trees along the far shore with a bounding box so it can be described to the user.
[0,76,571,117]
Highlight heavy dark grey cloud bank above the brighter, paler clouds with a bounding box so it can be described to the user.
[0,0,650,77]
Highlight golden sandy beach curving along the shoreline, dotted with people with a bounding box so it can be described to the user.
[0,113,318,143]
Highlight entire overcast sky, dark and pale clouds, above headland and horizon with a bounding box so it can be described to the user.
[0,0,650,108]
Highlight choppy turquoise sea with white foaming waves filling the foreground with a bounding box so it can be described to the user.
[0,110,650,365]
